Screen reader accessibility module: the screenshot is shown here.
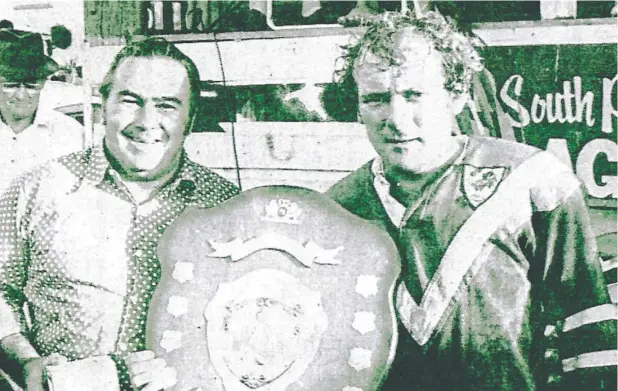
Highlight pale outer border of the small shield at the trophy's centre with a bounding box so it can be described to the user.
[203,268,328,391]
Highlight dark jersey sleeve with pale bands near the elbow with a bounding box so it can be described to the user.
[535,191,618,390]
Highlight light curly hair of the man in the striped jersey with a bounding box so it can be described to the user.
[335,10,483,94]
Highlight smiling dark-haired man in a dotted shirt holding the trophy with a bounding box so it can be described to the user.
[0,39,238,391]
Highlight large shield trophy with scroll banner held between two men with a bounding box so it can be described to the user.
[147,186,400,391]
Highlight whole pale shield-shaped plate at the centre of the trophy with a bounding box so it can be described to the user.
[205,269,328,391]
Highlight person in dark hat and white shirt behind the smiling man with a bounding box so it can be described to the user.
[0,29,84,192]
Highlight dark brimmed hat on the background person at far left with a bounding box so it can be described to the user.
[0,29,58,81]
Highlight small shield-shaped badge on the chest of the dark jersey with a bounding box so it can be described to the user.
[462,164,506,208]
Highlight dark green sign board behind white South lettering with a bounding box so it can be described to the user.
[484,44,618,201]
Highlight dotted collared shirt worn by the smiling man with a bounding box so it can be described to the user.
[0,147,238,388]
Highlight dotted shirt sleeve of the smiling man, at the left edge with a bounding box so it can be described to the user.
[0,177,28,339]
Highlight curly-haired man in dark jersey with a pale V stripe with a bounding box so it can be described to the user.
[328,11,617,391]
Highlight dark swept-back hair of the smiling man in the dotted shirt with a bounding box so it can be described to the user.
[99,37,201,131]
